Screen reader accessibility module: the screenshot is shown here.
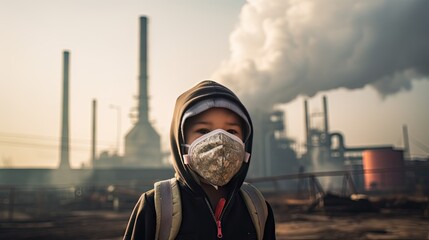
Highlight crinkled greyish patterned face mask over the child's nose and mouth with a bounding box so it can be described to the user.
[184,129,250,187]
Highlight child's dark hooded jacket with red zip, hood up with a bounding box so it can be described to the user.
[124,81,275,240]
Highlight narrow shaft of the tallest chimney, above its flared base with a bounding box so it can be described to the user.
[138,17,149,122]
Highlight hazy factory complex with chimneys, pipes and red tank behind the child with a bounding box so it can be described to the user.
[0,16,429,197]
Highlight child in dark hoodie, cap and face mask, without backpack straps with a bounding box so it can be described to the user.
[124,81,275,240]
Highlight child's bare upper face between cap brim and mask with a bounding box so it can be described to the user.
[185,108,243,144]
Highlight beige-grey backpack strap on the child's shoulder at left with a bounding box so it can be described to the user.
[154,178,182,240]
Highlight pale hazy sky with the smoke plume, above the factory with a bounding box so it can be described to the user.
[0,0,429,167]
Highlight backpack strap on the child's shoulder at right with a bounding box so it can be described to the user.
[240,182,268,240]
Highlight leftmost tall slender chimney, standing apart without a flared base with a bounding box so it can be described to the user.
[59,51,70,169]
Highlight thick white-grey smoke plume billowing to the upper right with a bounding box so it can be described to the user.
[212,0,429,108]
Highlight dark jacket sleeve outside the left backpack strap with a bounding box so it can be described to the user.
[123,190,156,240]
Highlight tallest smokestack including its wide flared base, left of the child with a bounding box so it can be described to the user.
[124,17,162,167]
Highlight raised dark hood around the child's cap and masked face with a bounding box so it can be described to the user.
[170,80,253,194]
